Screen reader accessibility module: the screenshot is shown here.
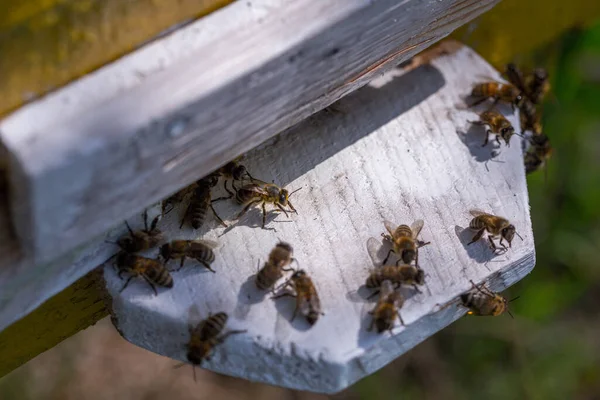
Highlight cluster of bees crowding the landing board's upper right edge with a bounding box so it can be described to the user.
[471,64,552,174]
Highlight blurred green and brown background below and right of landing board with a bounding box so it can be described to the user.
[0,11,600,400]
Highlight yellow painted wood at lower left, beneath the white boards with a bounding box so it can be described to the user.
[0,271,108,377]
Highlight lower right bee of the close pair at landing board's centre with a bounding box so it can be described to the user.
[273,270,323,325]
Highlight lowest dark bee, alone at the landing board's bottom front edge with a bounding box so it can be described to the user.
[186,312,246,366]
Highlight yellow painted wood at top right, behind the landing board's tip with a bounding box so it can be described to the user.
[452,0,600,70]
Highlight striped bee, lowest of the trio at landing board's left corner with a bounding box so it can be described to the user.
[116,251,173,295]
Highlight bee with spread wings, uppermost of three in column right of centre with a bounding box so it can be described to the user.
[381,219,430,266]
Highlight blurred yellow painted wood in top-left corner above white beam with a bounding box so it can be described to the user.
[0,0,232,116]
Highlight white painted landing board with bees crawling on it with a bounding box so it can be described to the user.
[104,44,535,393]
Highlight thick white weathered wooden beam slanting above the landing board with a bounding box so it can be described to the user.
[0,0,496,266]
